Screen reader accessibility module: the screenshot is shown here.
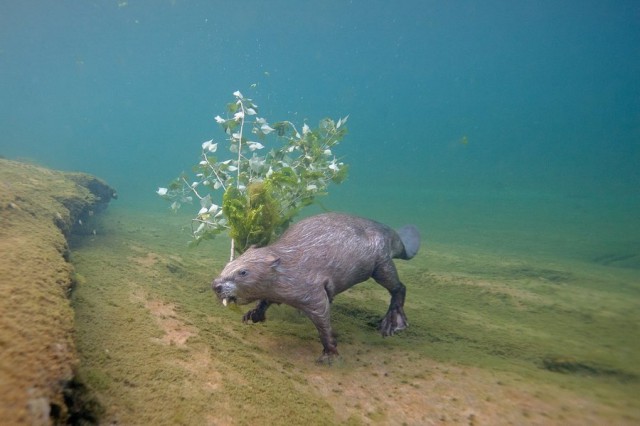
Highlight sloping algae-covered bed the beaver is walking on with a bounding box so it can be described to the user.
[73,211,640,424]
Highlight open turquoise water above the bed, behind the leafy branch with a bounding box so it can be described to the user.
[0,0,640,262]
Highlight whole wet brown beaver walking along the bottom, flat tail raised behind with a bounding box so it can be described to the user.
[211,213,420,363]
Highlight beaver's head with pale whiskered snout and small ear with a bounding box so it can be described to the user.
[211,248,280,306]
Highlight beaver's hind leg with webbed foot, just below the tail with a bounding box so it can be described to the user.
[371,259,409,337]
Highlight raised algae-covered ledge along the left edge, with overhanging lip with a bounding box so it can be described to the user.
[0,159,115,424]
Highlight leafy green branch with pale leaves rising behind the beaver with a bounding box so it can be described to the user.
[156,91,348,258]
